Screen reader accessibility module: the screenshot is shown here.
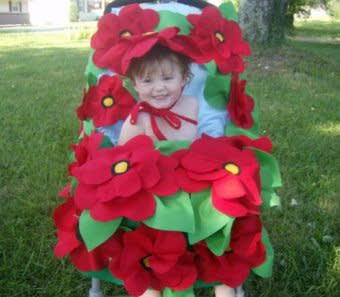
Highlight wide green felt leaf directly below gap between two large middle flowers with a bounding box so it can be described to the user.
[144,191,195,232]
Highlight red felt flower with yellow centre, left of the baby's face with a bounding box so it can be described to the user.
[77,75,135,127]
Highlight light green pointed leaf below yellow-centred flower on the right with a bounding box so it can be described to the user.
[188,189,234,244]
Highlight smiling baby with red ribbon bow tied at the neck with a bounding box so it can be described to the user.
[118,45,198,144]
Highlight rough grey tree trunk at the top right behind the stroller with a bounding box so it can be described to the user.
[239,0,289,43]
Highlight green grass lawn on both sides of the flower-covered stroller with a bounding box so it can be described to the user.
[0,19,340,297]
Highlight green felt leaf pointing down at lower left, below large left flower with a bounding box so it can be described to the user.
[79,210,122,251]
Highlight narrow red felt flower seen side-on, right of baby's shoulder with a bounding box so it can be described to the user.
[227,74,254,129]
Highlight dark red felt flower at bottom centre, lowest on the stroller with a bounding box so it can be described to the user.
[109,225,197,296]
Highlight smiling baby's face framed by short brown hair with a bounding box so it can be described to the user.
[134,61,185,108]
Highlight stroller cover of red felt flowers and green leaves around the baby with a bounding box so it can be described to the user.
[54,3,281,296]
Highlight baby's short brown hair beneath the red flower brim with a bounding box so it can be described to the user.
[126,45,192,81]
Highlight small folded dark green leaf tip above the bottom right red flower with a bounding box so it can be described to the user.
[206,218,234,256]
